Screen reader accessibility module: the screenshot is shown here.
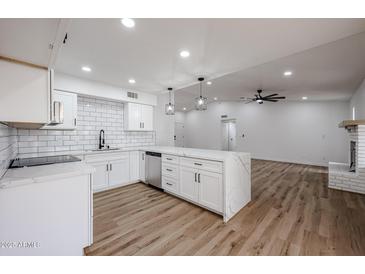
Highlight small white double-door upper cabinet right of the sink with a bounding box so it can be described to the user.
[124,103,153,131]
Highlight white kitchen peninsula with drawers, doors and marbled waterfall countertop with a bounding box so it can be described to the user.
[140,146,251,222]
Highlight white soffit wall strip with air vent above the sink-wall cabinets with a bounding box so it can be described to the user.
[54,72,157,106]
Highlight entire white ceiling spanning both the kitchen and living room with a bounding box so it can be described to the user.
[0,19,365,107]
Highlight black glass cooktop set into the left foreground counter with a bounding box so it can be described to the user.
[9,155,81,168]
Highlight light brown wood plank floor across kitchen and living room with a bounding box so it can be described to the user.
[85,160,365,255]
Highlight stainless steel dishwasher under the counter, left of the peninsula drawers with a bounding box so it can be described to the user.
[146,151,162,188]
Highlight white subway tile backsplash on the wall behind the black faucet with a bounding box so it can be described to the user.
[16,96,155,157]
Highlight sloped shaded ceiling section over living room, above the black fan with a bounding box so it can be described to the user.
[175,32,365,110]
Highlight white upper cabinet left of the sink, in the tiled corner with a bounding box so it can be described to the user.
[42,90,77,130]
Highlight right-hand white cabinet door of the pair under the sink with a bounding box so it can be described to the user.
[109,157,130,186]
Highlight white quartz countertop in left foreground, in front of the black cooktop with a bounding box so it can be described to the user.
[0,162,95,190]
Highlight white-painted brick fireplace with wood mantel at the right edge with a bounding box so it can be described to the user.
[328,120,365,194]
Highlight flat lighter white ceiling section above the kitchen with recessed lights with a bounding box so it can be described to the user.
[56,19,365,93]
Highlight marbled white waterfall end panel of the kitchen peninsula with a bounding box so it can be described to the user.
[223,153,251,222]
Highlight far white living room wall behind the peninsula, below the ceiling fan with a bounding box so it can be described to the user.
[185,102,349,165]
